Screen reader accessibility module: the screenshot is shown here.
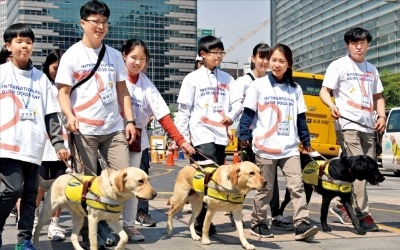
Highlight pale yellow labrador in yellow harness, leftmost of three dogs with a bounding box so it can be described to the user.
[33,167,157,250]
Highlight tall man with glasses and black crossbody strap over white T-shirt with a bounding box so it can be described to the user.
[55,0,136,245]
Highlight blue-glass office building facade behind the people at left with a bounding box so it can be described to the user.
[5,0,197,103]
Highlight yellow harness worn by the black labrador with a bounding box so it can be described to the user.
[303,161,352,193]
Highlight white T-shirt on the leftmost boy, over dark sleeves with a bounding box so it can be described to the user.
[0,62,60,165]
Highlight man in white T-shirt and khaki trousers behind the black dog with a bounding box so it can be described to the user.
[319,27,386,231]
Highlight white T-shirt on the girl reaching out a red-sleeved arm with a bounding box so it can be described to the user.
[126,73,170,149]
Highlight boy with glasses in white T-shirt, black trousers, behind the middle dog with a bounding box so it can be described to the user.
[177,36,240,234]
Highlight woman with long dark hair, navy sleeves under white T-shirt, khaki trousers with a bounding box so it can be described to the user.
[239,44,318,240]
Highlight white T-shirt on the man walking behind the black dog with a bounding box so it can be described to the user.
[322,56,383,133]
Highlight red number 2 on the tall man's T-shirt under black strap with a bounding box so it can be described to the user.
[72,72,105,126]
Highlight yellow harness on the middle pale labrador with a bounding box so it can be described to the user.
[193,166,245,204]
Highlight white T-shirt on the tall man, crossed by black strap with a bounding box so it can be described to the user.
[55,42,127,135]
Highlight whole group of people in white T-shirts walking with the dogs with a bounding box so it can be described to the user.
[0,0,386,250]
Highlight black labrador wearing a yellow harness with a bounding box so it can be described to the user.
[280,154,385,235]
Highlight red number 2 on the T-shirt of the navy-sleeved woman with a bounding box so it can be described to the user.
[254,103,282,154]
